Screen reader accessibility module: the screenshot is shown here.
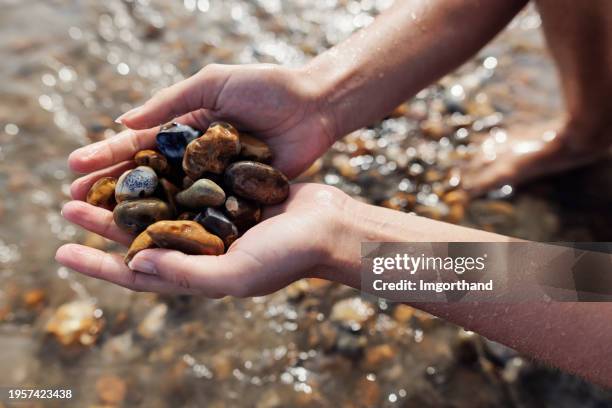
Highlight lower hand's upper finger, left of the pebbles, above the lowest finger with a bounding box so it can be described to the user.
[62,201,134,246]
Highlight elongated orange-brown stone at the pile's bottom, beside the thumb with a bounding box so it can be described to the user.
[147,221,224,255]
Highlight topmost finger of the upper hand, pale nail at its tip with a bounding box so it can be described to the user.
[117,64,232,129]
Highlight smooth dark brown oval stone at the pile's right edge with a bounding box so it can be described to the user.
[225,161,289,205]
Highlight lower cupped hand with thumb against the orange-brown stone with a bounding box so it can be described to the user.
[56,184,350,298]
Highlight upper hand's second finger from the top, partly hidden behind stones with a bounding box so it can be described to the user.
[68,109,210,173]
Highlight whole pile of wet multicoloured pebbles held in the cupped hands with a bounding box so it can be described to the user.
[87,122,289,263]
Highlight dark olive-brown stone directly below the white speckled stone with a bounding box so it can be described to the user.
[113,198,172,234]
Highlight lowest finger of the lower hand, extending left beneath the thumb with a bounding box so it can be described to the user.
[55,244,196,294]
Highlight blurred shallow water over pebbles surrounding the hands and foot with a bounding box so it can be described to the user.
[0,0,612,408]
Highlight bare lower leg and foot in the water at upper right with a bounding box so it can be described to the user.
[464,0,612,195]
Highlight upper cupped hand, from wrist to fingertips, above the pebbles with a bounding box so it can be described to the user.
[69,64,336,178]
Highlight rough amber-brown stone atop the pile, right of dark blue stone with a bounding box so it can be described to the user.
[183,122,240,180]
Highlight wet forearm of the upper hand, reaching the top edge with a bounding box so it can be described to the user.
[306,0,526,137]
